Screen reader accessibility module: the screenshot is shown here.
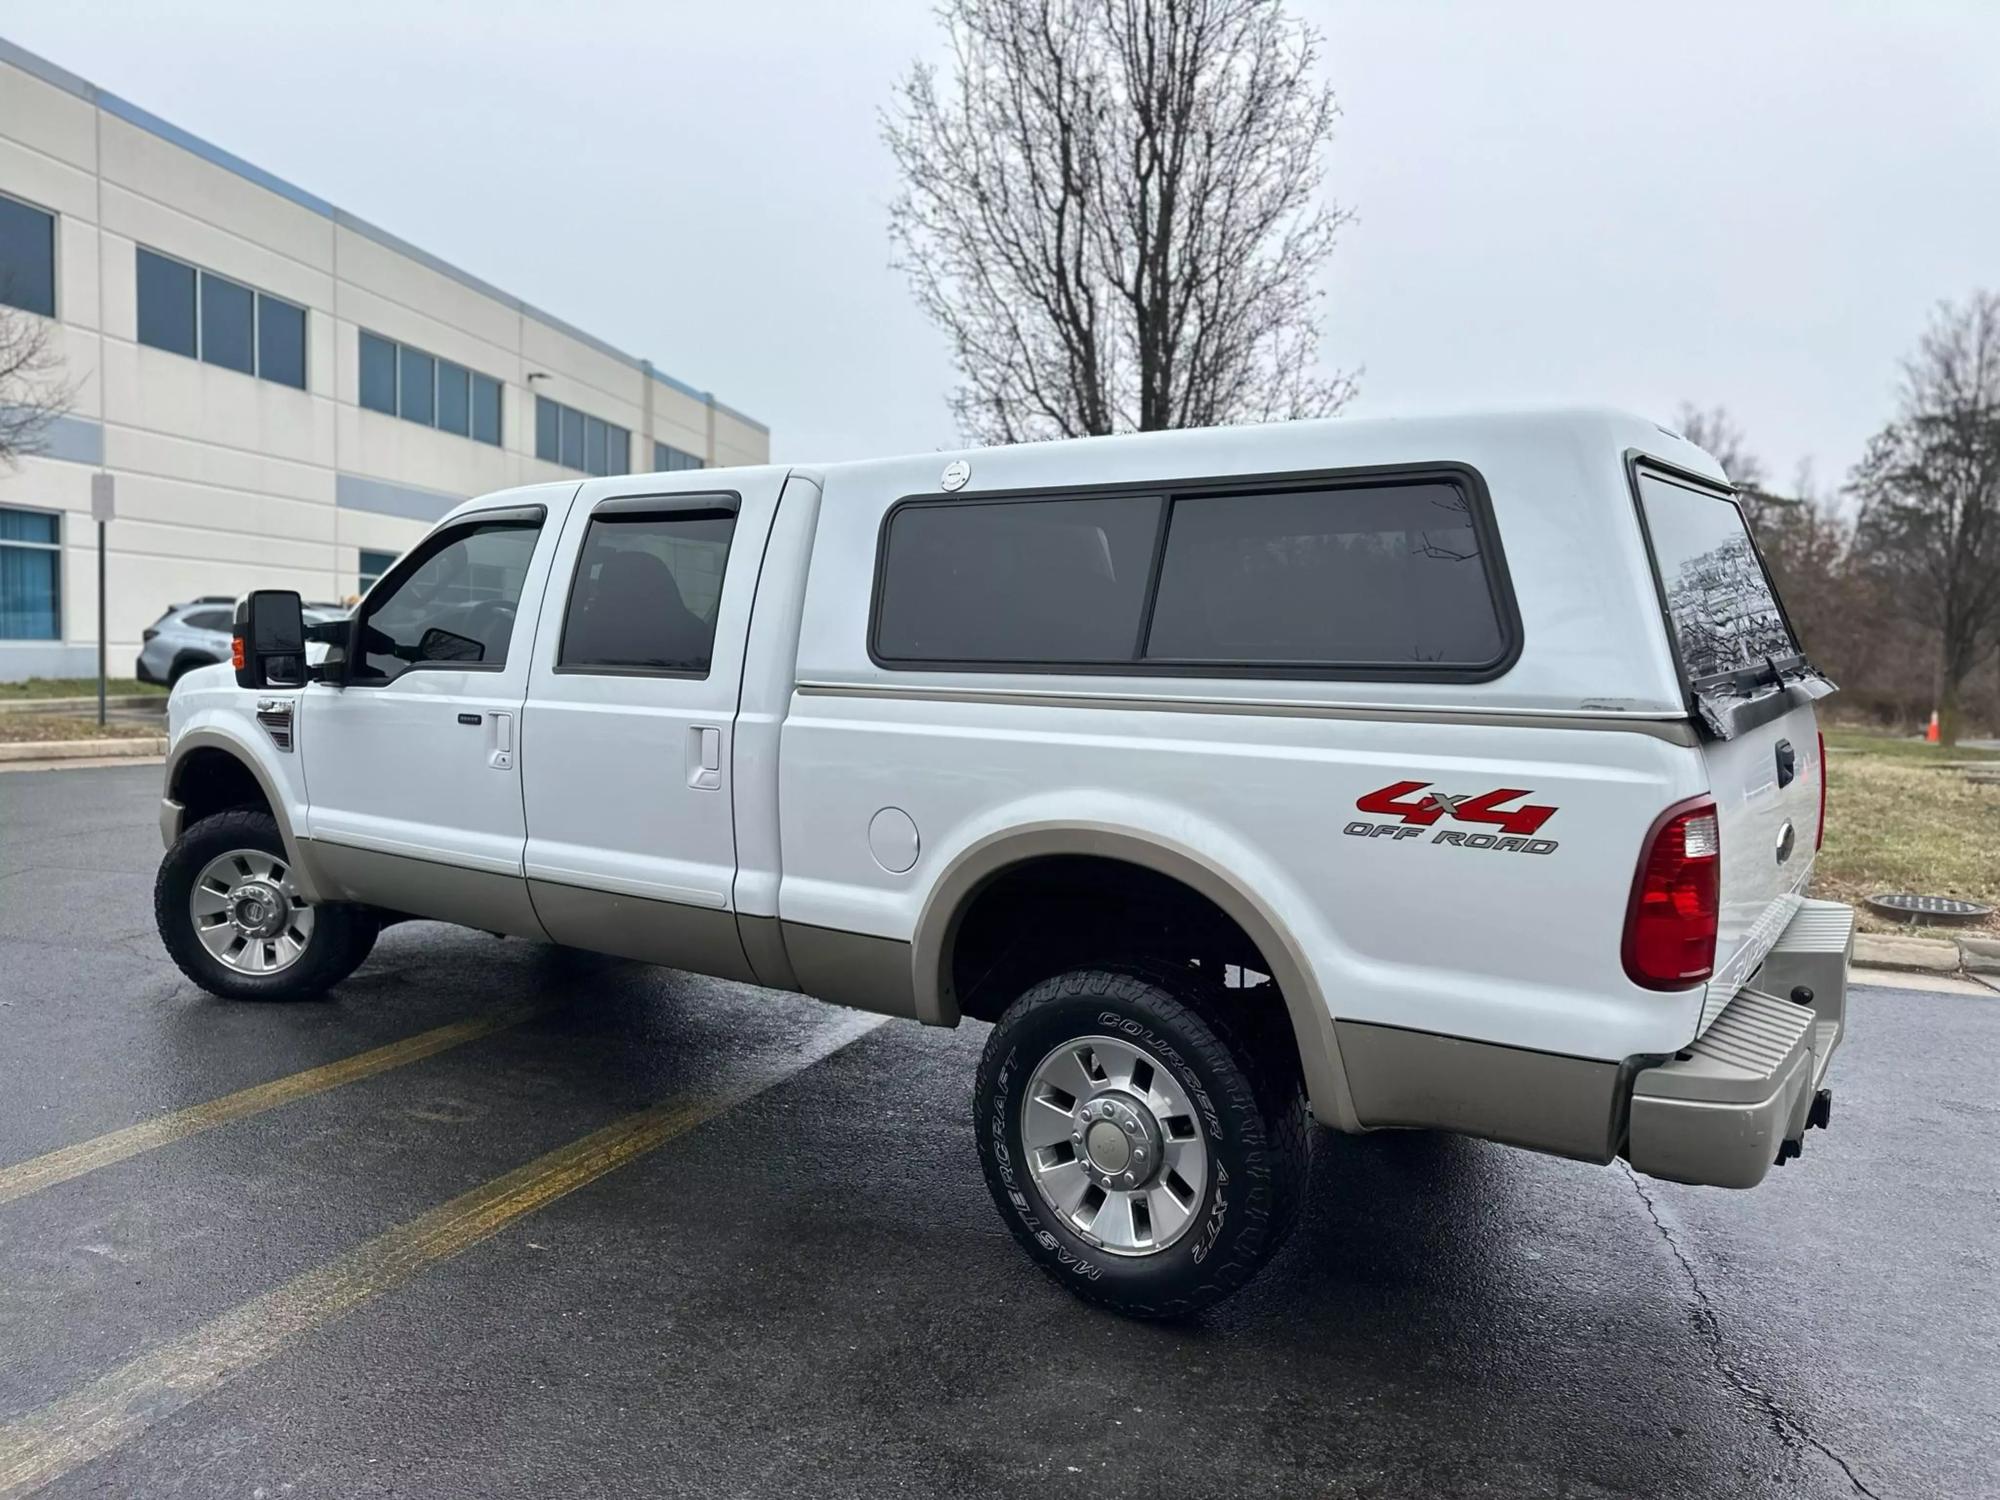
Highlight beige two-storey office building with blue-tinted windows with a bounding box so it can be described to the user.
[0,40,770,680]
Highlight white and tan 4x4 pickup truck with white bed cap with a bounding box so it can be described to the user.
[156,412,1852,1314]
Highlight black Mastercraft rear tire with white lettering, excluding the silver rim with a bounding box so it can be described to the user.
[974,966,1312,1318]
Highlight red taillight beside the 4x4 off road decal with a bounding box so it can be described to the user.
[1624,796,1722,990]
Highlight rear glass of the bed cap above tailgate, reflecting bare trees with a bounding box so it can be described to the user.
[1638,474,1798,684]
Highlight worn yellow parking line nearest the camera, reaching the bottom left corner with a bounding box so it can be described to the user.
[0,1014,886,1500]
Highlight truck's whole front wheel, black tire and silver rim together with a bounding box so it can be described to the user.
[152,808,378,1000]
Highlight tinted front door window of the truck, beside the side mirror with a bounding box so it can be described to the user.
[348,520,542,682]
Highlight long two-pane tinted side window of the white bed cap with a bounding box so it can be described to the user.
[874,476,1512,676]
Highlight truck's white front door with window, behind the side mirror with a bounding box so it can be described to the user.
[298,504,560,900]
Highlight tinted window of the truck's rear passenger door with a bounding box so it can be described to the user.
[556,506,736,678]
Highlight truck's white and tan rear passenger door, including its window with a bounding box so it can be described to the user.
[522,468,784,978]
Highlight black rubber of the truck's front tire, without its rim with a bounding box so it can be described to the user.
[152,808,380,1000]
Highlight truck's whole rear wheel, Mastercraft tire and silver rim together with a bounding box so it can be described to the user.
[974,970,1310,1318]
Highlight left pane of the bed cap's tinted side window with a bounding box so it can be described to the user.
[876,494,1162,662]
